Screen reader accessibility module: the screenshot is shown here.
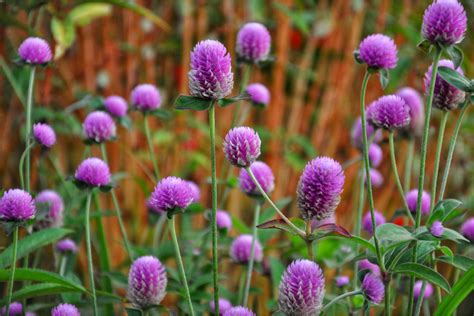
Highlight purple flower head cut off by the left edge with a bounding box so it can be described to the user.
[0,189,36,222]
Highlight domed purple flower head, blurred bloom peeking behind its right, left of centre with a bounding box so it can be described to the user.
[150,177,194,213]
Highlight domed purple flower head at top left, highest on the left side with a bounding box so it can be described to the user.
[18,37,53,65]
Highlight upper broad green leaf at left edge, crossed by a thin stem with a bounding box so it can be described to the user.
[0,228,72,268]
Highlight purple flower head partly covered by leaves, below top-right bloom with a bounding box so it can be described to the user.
[424,59,466,111]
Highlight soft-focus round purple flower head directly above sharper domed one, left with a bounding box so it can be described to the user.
[82,111,116,143]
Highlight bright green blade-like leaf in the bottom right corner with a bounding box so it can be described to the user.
[434,268,474,316]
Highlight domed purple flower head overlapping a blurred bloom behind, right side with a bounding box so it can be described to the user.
[367,95,410,131]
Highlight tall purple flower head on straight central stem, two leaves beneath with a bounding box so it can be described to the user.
[188,40,234,100]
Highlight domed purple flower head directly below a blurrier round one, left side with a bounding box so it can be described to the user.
[75,157,110,187]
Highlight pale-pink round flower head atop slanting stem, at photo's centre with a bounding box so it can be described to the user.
[224,126,261,168]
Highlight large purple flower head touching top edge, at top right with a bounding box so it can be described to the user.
[421,0,467,46]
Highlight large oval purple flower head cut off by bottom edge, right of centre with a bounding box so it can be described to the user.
[278,259,325,316]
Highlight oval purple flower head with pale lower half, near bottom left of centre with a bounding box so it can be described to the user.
[127,256,168,308]
